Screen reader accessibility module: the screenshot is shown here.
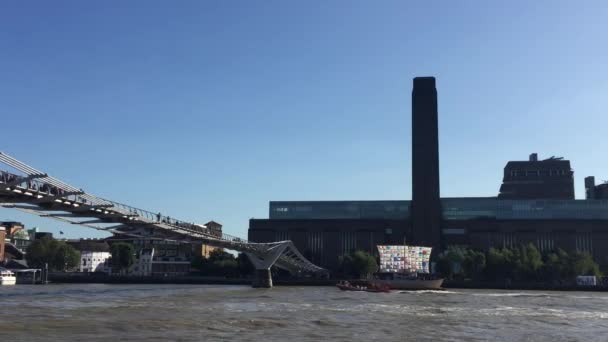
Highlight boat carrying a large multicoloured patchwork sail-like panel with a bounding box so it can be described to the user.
[373,245,443,290]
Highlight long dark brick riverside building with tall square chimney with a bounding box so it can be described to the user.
[249,77,608,270]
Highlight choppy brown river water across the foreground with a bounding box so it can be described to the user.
[0,284,608,342]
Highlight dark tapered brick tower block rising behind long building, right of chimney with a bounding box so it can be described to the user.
[498,153,574,199]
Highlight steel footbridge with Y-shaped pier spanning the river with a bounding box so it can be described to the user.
[0,152,327,287]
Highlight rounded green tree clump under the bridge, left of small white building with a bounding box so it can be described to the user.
[25,238,80,271]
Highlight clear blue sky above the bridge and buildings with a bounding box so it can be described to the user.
[0,1,608,237]
